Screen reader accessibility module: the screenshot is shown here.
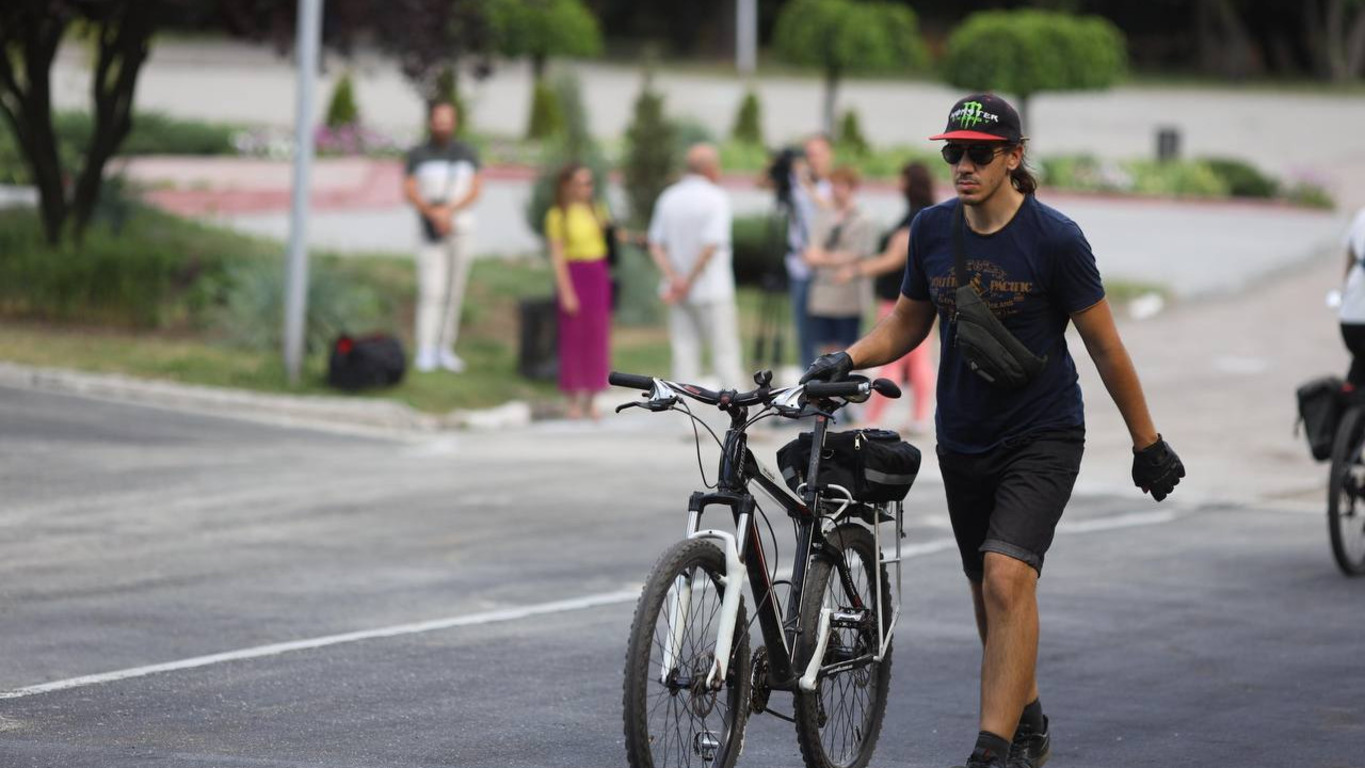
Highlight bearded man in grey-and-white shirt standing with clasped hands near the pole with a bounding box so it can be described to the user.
[403,101,483,374]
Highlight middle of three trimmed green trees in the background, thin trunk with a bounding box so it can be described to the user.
[774,0,928,131]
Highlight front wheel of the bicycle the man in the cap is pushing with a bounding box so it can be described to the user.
[622,539,751,768]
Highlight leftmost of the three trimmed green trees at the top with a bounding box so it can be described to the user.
[487,0,602,139]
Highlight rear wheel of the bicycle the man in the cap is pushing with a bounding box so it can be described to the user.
[794,524,891,768]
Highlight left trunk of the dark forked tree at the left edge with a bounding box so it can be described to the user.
[0,3,68,246]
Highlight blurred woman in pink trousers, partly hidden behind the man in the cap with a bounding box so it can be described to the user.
[838,161,934,435]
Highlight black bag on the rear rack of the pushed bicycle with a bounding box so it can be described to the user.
[777,430,920,503]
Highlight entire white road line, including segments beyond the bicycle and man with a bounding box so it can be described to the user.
[0,510,1179,700]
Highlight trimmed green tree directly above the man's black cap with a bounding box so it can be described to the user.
[943,10,1127,132]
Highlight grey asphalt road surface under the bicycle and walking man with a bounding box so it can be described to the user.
[0,389,1365,768]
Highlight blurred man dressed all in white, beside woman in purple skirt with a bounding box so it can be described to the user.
[648,143,745,389]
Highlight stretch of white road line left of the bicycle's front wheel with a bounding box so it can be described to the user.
[0,589,640,698]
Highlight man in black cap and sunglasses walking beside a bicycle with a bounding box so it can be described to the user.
[801,94,1185,768]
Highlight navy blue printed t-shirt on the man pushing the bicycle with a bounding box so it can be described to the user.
[901,195,1104,453]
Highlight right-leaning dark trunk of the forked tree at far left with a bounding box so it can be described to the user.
[72,3,153,241]
